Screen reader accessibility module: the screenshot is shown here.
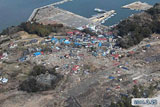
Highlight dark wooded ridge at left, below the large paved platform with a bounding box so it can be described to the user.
[0,22,74,37]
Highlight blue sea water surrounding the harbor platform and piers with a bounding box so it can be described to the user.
[0,0,160,31]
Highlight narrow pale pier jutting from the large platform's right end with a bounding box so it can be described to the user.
[89,10,115,23]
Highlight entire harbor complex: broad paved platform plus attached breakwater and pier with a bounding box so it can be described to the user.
[28,0,115,28]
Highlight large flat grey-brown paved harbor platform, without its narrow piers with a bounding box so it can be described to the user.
[30,6,92,28]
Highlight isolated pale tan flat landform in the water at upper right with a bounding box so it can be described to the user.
[122,1,152,10]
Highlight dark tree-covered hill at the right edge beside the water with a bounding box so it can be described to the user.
[114,3,160,48]
